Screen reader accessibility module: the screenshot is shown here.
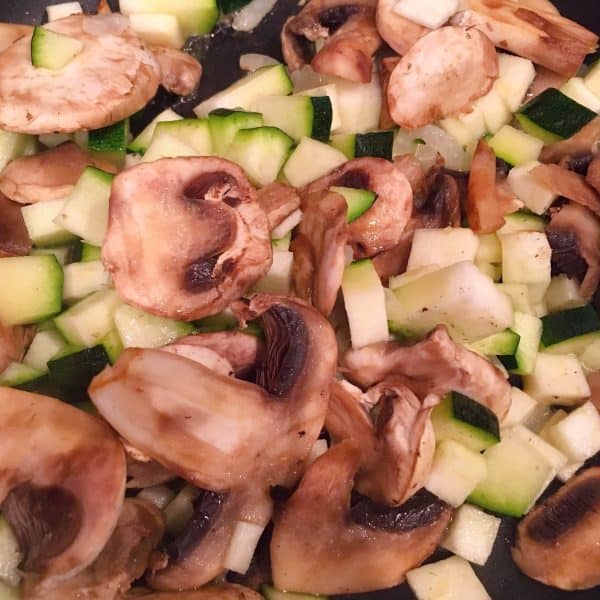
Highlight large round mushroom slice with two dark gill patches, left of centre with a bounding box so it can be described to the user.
[102,157,272,321]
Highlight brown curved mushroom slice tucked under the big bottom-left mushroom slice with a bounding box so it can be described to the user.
[23,498,165,600]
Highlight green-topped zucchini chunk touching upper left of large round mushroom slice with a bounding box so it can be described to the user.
[56,167,113,246]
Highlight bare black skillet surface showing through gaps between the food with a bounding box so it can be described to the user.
[0,0,600,600]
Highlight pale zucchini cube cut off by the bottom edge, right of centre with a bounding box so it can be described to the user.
[406,556,491,600]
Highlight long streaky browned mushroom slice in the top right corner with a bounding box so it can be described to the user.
[452,0,598,77]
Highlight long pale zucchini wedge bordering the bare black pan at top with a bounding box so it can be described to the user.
[194,65,293,117]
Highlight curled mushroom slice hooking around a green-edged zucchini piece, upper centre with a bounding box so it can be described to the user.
[306,158,413,258]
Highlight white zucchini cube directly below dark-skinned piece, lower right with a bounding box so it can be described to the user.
[424,440,487,507]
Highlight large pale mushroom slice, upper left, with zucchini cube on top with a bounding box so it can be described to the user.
[0,14,160,134]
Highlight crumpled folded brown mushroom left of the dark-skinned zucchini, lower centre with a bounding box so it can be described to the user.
[325,379,439,506]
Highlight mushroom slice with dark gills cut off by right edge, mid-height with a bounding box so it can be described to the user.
[546,203,600,298]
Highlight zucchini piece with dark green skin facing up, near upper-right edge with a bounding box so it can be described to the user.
[515,86,596,144]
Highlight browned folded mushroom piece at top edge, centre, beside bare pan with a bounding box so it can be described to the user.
[281,0,381,83]
